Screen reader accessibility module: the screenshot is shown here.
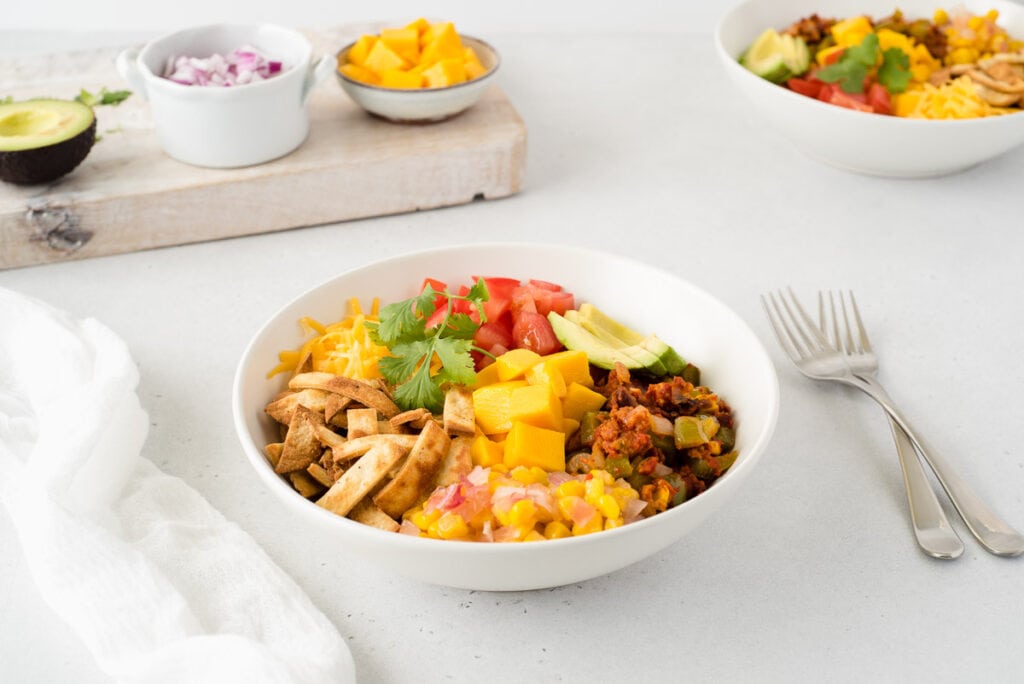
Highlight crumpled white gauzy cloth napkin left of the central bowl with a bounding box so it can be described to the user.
[0,288,355,684]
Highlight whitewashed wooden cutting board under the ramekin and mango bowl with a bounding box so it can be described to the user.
[0,27,526,269]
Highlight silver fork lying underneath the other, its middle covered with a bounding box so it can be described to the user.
[818,292,964,560]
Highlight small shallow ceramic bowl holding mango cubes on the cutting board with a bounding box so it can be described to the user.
[338,36,501,123]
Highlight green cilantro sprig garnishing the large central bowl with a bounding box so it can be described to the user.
[367,279,489,413]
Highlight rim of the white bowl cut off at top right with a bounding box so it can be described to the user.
[714,0,1024,130]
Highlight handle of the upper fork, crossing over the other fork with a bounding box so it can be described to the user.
[847,376,1024,556]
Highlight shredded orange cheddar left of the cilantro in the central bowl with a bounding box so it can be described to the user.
[267,298,388,380]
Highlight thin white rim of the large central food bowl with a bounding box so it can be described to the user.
[231,242,780,555]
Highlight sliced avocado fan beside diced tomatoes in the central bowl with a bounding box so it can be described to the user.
[548,304,686,377]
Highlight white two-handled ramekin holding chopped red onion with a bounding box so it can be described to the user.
[117,24,334,168]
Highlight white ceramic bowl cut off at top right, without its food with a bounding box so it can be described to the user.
[716,0,1024,178]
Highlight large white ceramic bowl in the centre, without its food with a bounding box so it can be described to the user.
[232,244,778,591]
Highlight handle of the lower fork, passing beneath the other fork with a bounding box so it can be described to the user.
[888,418,964,560]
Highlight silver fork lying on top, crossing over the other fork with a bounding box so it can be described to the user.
[762,290,1024,556]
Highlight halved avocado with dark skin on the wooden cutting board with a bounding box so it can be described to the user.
[0,99,96,184]
